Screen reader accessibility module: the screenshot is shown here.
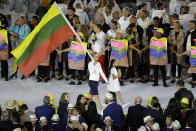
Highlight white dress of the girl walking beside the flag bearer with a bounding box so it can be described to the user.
[107,67,120,92]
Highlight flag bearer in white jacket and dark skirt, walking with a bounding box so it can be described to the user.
[88,52,108,111]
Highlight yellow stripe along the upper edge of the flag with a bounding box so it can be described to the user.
[11,4,60,59]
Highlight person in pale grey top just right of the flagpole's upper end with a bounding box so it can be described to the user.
[75,2,89,25]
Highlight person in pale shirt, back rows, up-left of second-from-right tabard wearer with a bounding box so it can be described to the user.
[137,10,152,31]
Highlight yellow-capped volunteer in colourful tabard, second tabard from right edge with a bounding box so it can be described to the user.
[150,28,168,87]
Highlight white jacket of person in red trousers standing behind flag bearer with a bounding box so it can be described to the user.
[89,31,107,53]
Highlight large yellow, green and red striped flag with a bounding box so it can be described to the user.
[12,3,74,77]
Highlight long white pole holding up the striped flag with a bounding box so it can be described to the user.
[54,2,95,62]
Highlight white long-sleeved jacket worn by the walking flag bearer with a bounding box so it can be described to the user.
[88,61,108,83]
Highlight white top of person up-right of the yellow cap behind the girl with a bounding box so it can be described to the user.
[118,16,131,37]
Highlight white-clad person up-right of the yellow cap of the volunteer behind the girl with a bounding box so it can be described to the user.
[118,7,133,36]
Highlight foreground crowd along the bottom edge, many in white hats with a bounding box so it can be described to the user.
[0,79,196,131]
